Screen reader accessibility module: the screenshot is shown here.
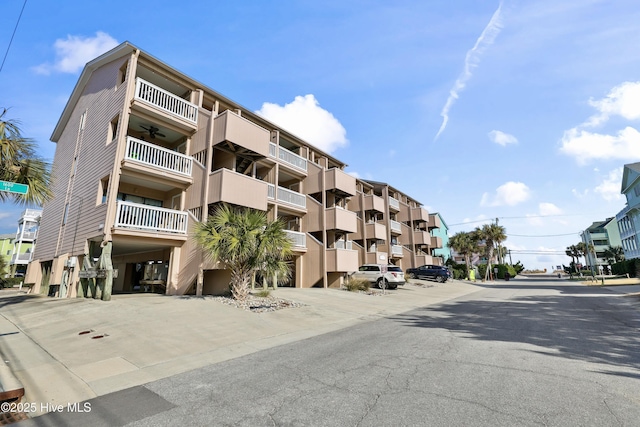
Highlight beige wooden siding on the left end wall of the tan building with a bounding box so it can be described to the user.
[34,54,127,261]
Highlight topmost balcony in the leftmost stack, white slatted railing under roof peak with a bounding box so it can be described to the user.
[134,77,198,130]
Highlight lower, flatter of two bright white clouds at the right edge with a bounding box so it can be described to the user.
[560,126,640,164]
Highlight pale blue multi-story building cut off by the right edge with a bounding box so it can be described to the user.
[616,162,640,259]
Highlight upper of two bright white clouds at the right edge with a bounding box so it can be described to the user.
[585,82,640,126]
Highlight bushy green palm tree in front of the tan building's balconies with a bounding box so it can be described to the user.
[195,205,292,301]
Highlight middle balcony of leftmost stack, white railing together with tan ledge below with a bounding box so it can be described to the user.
[122,136,193,188]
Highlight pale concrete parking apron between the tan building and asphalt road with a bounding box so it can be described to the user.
[0,280,482,415]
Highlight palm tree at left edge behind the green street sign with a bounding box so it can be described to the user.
[0,108,53,206]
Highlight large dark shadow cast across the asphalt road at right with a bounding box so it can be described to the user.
[393,285,640,375]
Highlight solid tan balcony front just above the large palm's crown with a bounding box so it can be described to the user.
[208,169,268,211]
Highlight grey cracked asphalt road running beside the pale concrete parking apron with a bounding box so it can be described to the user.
[21,279,640,426]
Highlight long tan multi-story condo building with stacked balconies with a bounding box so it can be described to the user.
[26,43,438,295]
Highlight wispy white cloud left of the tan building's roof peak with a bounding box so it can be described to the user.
[34,31,118,75]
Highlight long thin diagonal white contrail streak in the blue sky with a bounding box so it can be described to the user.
[434,3,502,140]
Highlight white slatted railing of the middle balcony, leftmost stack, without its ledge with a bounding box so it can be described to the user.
[125,137,193,176]
